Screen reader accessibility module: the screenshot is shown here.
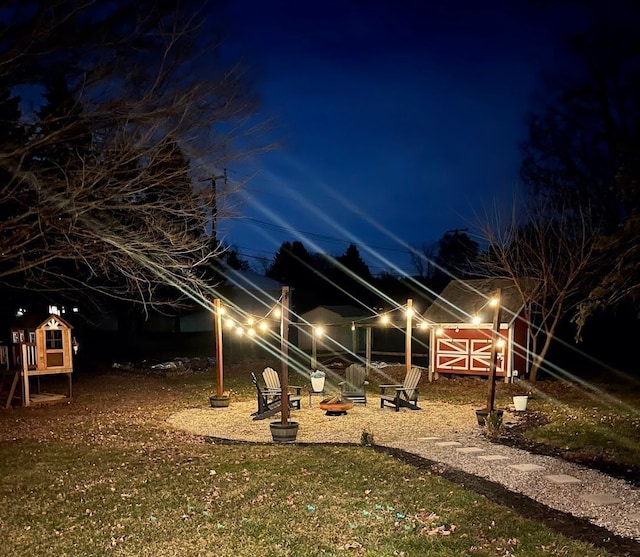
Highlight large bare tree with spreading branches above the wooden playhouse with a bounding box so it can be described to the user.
[0,0,264,312]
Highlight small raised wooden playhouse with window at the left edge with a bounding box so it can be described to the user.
[0,314,73,408]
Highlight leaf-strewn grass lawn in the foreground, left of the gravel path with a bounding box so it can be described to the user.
[0,360,637,557]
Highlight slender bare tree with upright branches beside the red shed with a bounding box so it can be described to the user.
[478,199,598,382]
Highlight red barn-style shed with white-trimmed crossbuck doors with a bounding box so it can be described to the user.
[423,279,529,381]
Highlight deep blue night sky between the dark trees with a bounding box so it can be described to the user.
[220,0,584,273]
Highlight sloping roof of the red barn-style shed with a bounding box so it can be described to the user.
[422,278,524,324]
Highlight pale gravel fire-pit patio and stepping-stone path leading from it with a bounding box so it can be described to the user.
[168,397,640,540]
